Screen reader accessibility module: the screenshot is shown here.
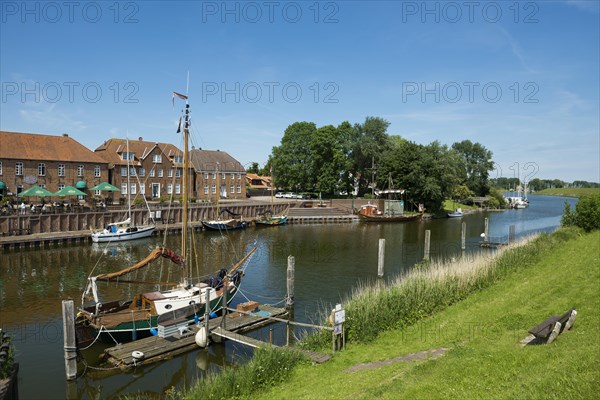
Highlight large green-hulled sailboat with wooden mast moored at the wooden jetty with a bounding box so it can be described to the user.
[76,94,256,345]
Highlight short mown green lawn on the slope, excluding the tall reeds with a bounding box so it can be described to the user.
[249,231,600,399]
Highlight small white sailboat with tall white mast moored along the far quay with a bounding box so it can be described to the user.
[91,139,156,243]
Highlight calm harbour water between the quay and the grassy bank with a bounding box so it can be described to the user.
[0,195,576,399]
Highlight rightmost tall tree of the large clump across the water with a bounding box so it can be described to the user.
[452,140,494,196]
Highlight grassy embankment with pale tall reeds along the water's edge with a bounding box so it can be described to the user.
[180,230,600,399]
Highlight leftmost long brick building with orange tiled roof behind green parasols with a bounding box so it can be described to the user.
[0,131,108,196]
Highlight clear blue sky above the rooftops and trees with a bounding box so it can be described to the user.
[0,0,600,182]
